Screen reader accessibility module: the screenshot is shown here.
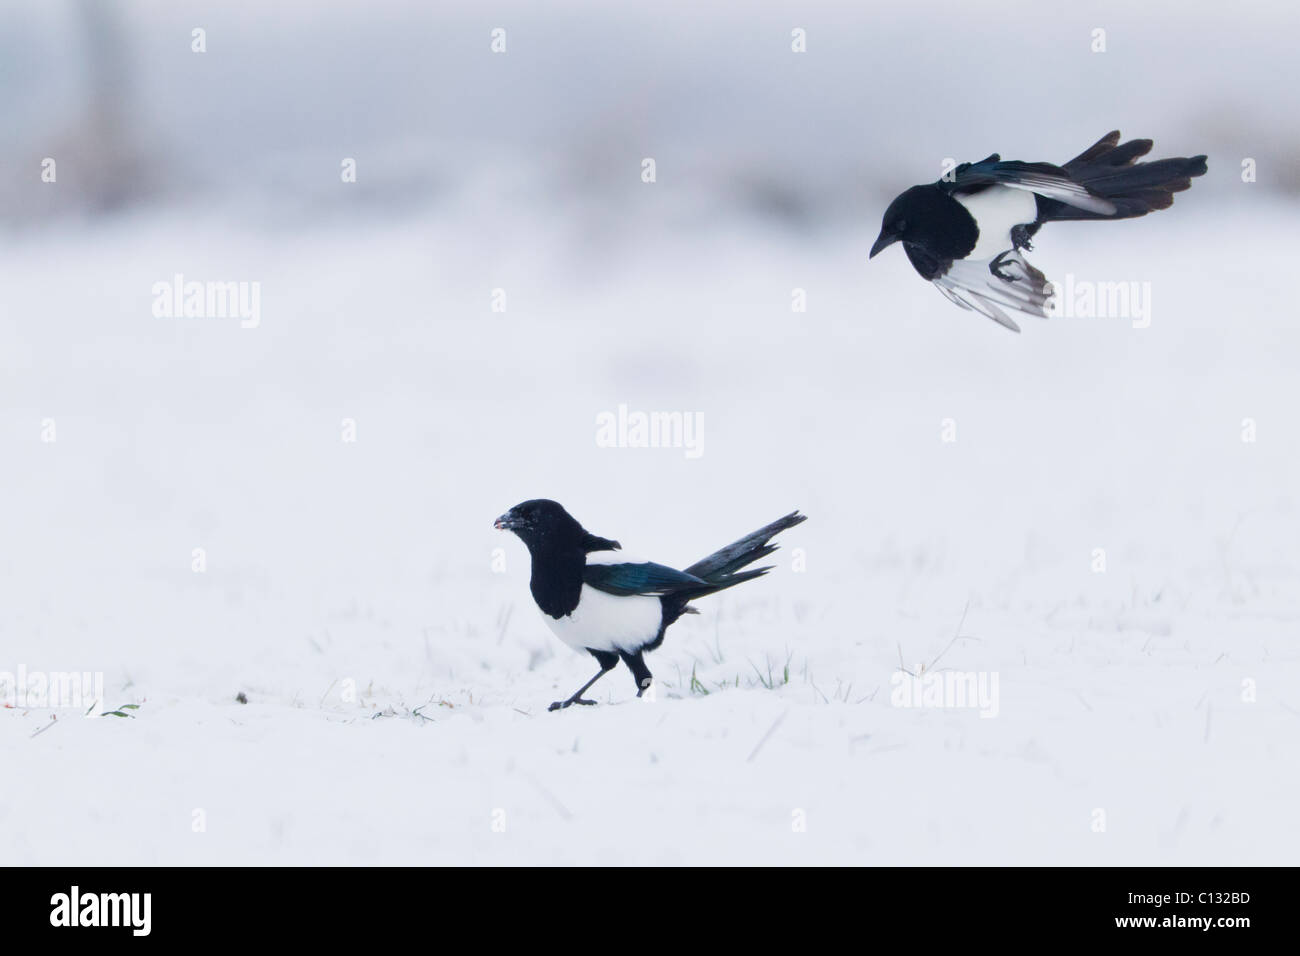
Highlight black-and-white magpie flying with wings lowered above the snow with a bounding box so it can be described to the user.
[867,130,1205,332]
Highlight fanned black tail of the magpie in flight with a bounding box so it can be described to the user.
[1039,130,1205,222]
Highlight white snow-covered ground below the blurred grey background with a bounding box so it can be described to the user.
[0,190,1300,865]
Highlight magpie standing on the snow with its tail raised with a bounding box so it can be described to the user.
[493,498,806,710]
